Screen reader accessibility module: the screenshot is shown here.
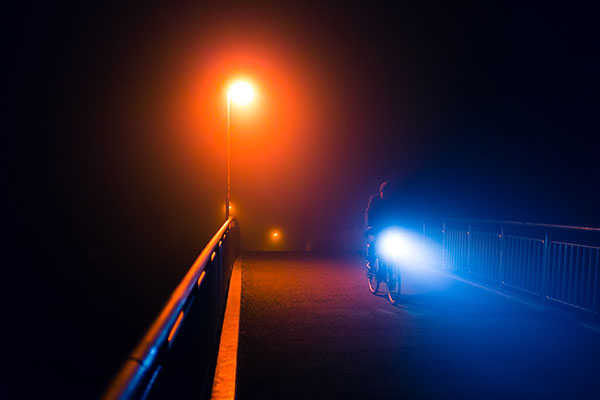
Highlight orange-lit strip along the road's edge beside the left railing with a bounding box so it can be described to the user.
[210,258,242,400]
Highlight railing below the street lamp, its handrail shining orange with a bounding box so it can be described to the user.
[104,218,240,399]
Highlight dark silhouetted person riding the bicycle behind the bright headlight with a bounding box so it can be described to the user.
[364,181,398,268]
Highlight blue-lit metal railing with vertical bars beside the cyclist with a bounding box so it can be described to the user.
[423,219,600,315]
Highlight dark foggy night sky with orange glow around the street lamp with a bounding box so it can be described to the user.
[2,2,600,396]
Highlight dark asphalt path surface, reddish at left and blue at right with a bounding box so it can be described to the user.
[236,254,600,399]
